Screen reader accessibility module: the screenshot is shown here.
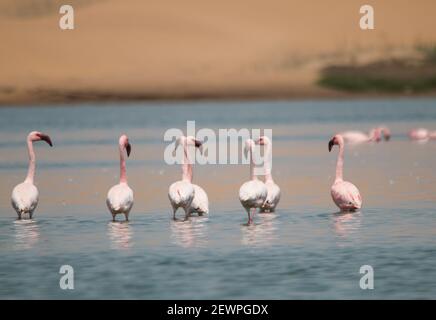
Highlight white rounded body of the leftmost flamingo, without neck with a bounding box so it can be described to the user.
[11,182,39,219]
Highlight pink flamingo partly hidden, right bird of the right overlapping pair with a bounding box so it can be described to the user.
[256,136,280,212]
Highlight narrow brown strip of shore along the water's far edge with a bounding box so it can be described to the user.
[0,88,436,108]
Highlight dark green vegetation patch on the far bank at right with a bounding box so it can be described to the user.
[318,46,436,93]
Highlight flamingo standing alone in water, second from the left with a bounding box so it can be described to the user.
[106,134,133,221]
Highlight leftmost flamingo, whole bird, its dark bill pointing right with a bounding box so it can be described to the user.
[11,131,53,219]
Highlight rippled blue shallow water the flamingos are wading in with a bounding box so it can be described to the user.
[0,99,436,299]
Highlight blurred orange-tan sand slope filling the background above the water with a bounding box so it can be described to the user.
[0,0,436,105]
